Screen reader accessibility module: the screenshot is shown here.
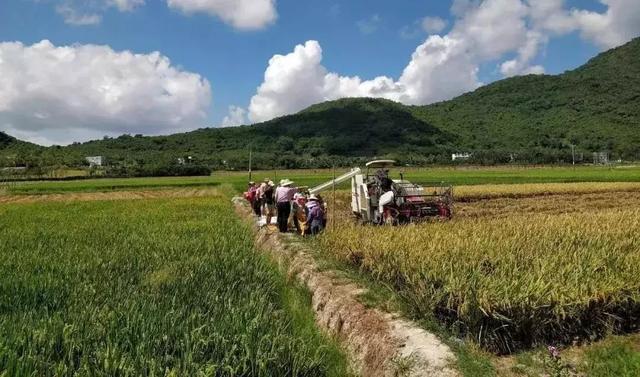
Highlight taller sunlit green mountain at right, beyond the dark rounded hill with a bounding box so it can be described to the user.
[414,38,640,159]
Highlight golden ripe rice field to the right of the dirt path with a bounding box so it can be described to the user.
[319,183,640,353]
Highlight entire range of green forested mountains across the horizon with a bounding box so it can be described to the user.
[0,38,640,169]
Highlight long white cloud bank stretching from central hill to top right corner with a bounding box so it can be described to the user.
[248,0,640,122]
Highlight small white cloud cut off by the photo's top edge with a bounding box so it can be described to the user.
[167,0,278,30]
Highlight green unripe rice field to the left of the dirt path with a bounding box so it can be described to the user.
[0,194,347,376]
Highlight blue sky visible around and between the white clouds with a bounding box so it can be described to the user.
[0,0,640,143]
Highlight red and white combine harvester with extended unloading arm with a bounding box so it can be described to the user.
[309,160,453,225]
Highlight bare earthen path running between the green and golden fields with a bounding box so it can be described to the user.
[233,198,459,377]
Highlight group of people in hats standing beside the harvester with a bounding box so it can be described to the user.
[245,178,327,235]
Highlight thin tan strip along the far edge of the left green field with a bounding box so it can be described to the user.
[0,188,218,204]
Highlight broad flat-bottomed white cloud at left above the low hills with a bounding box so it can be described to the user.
[0,40,211,144]
